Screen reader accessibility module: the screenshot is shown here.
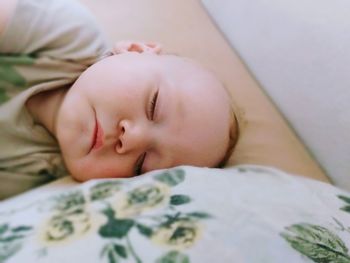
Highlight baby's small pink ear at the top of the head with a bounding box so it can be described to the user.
[112,41,162,54]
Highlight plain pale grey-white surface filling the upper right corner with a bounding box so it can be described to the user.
[202,0,350,190]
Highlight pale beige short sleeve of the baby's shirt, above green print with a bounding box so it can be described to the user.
[0,0,107,62]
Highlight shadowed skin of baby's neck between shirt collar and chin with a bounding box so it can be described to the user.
[26,88,68,136]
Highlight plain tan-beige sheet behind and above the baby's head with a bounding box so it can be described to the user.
[80,0,329,184]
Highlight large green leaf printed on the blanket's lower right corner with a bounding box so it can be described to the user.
[281,223,350,263]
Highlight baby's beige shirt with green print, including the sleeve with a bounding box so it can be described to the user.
[0,0,107,200]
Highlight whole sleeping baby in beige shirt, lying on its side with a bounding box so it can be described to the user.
[0,0,238,198]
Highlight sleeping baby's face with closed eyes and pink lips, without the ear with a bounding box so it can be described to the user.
[56,53,230,181]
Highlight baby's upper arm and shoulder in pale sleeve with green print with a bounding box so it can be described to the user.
[0,0,107,101]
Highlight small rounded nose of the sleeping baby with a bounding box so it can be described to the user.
[116,120,150,154]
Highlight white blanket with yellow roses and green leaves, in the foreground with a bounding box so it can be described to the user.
[0,166,350,263]
